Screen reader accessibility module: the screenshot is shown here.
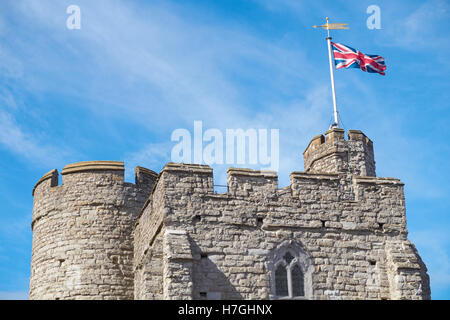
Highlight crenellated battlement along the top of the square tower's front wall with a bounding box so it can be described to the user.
[151,161,398,209]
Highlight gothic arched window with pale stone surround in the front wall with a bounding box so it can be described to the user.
[268,241,314,299]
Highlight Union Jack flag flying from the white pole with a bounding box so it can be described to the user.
[331,42,386,76]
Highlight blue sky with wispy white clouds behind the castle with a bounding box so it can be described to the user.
[0,0,450,299]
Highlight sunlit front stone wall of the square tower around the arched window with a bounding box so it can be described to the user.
[135,132,430,299]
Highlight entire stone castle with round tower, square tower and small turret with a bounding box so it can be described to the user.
[30,128,430,299]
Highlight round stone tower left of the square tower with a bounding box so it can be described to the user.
[30,161,157,299]
